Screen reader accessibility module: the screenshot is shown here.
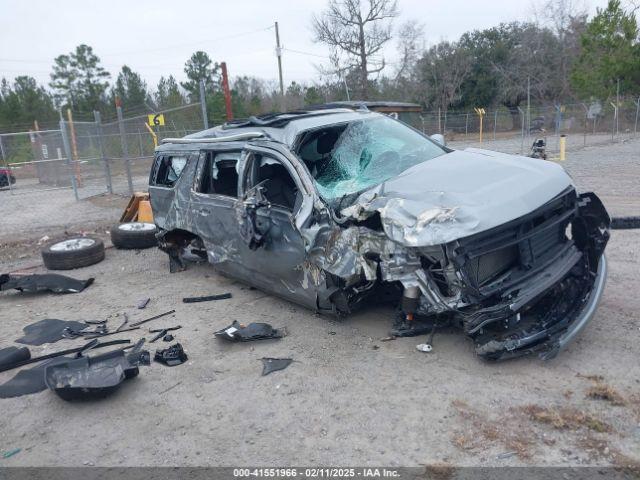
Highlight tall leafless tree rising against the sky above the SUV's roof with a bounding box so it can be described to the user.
[312,0,398,100]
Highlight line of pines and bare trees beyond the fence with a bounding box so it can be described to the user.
[0,0,640,131]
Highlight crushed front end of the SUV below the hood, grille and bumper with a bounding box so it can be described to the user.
[399,187,610,360]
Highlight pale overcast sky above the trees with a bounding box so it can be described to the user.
[0,0,606,88]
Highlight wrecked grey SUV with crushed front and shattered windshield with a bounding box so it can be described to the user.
[149,109,610,360]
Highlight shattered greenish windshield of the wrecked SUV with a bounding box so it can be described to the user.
[299,116,446,200]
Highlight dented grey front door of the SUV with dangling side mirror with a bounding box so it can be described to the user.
[240,147,317,308]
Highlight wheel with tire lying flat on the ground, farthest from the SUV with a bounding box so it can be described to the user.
[42,237,104,270]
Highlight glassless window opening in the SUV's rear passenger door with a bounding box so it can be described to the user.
[196,152,240,198]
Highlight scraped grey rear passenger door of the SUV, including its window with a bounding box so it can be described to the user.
[191,150,244,276]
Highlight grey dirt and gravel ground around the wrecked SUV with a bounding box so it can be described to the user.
[0,135,640,466]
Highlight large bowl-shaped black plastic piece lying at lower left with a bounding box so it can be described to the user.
[44,339,151,400]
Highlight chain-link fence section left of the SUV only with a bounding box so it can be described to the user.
[0,103,203,199]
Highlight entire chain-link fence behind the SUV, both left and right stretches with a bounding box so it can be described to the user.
[0,98,640,199]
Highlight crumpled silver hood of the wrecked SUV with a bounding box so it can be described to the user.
[341,148,573,247]
